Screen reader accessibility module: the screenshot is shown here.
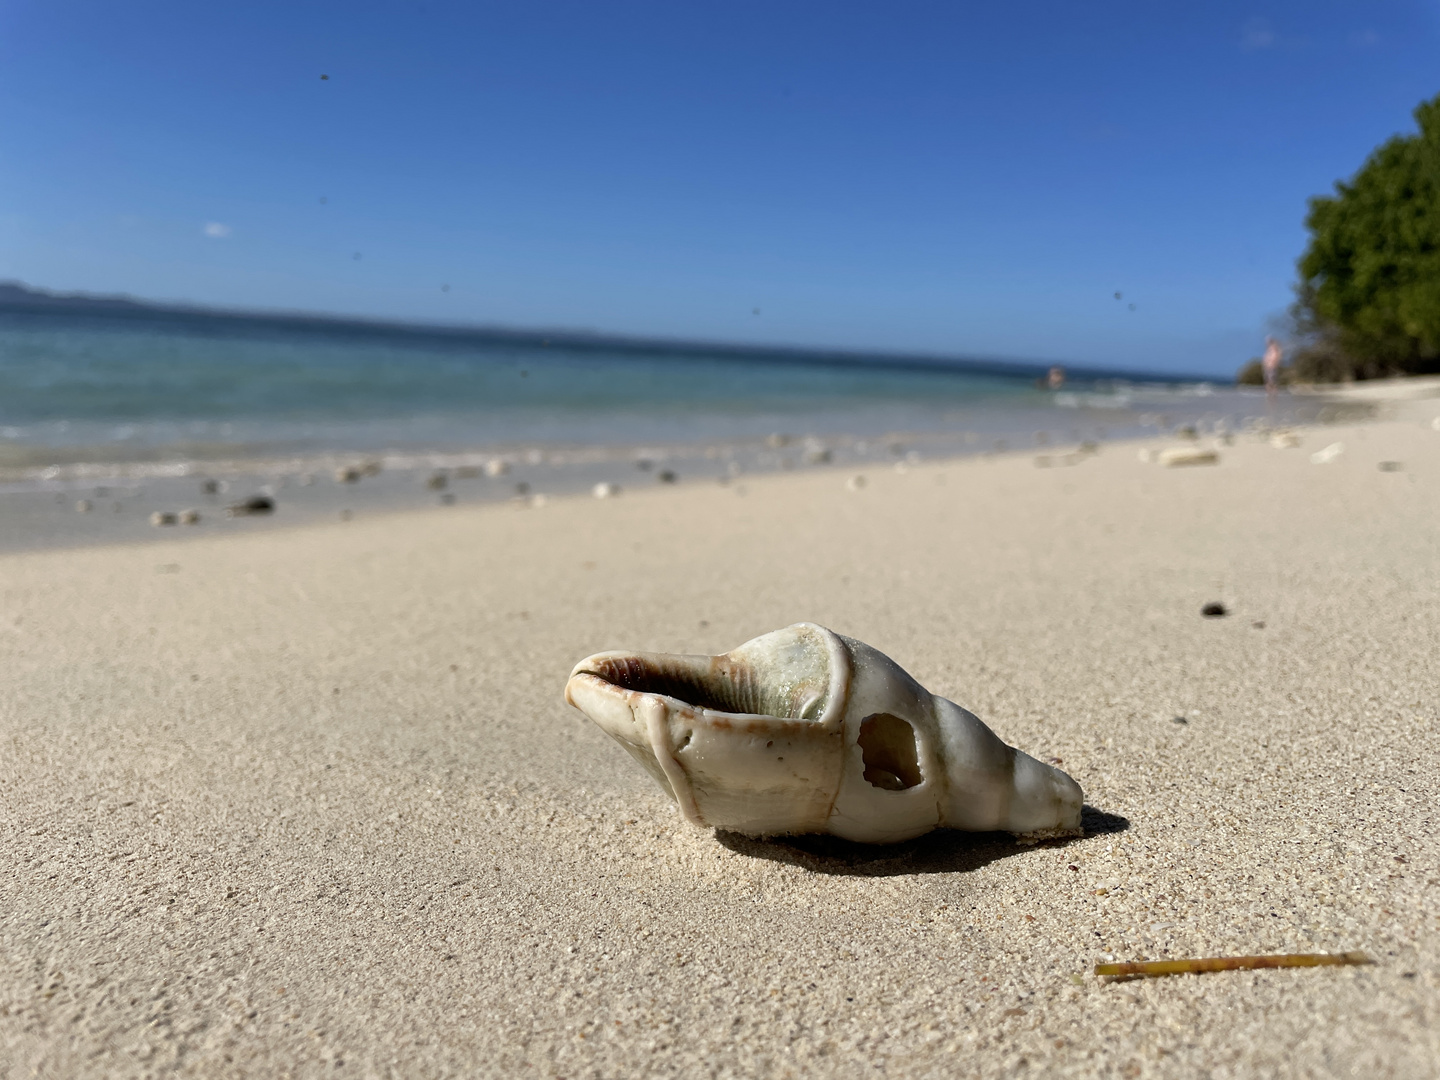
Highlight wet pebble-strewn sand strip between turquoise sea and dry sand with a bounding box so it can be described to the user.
[0,393,1395,550]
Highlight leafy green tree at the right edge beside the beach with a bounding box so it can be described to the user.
[1295,96,1440,379]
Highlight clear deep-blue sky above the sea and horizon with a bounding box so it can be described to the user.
[0,0,1440,373]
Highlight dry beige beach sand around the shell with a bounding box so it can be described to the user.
[0,405,1440,1077]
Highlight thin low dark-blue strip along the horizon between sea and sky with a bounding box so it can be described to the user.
[0,281,1211,383]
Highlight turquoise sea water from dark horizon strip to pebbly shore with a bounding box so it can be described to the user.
[0,312,1284,474]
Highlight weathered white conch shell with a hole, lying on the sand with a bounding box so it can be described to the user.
[564,622,1081,844]
